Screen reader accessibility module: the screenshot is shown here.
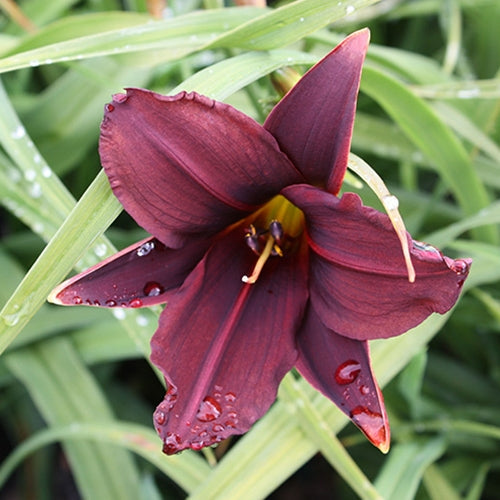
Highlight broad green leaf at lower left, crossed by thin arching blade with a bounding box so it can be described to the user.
[5,338,143,500]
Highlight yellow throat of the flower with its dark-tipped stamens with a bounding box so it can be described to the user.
[241,195,304,285]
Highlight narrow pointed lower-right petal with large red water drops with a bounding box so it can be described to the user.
[296,306,390,453]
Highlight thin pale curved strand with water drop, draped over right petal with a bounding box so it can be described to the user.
[347,153,415,283]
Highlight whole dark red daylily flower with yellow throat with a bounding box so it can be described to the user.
[51,30,470,454]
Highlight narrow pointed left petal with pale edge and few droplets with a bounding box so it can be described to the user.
[48,238,209,307]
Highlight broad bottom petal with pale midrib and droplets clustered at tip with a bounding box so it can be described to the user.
[151,226,307,454]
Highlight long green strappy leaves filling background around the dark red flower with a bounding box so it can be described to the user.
[0,0,500,500]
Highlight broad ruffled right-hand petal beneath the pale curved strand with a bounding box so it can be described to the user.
[282,185,471,340]
